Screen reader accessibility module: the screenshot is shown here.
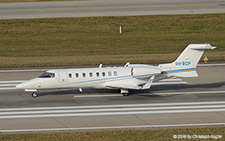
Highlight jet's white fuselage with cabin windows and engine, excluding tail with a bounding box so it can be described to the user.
[17,65,161,91]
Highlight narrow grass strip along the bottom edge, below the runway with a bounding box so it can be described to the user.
[0,127,225,141]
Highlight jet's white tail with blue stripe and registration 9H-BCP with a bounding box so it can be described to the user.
[159,44,216,77]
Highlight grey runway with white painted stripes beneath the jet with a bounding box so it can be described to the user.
[0,64,225,134]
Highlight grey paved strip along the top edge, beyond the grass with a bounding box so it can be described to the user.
[0,0,225,19]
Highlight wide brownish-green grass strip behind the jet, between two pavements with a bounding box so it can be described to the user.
[0,14,225,67]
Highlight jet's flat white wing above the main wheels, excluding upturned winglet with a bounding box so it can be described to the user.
[105,82,142,90]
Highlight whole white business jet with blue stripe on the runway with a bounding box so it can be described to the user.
[16,44,216,98]
